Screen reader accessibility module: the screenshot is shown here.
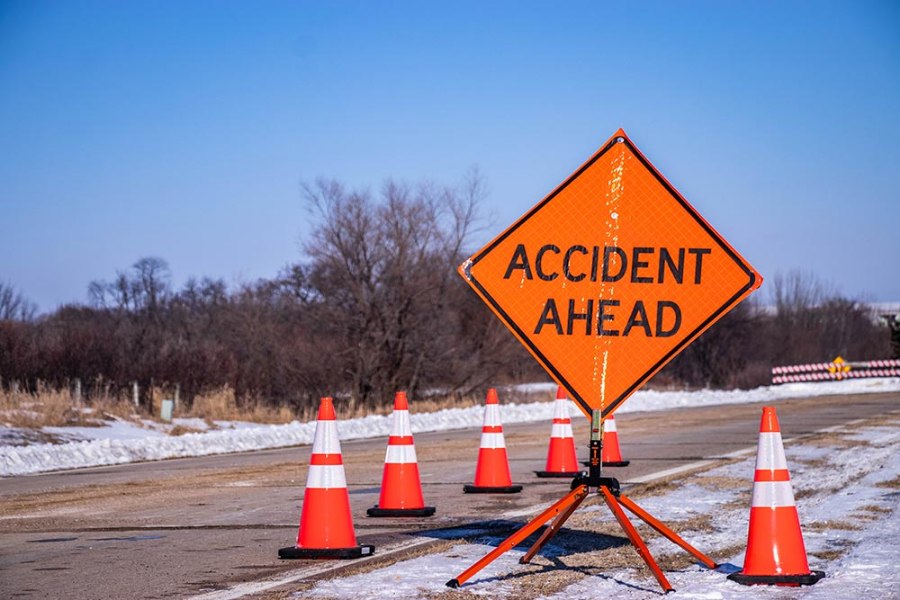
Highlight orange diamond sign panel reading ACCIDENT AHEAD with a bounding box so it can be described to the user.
[459,129,762,418]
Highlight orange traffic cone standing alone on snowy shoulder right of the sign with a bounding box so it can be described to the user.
[728,406,825,586]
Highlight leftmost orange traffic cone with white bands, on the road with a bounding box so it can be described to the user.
[278,398,375,558]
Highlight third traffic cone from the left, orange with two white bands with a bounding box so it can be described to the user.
[463,388,522,494]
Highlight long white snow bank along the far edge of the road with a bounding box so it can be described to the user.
[0,378,900,476]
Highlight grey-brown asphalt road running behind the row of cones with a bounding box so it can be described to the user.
[0,393,900,599]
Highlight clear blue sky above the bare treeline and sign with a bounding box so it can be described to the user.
[0,1,900,311]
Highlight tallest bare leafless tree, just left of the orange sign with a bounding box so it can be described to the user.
[304,173,483,404]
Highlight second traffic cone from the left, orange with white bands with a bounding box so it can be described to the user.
[366,392,434,517]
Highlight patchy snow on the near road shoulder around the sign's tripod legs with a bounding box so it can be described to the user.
[293,427,900,600]
